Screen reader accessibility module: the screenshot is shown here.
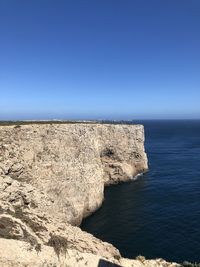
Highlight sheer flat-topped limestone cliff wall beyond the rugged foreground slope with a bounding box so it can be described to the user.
[0,124,147,225]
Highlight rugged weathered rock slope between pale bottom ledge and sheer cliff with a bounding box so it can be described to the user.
[0,176,120,258]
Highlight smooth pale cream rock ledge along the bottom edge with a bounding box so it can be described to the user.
[0,239,178,267]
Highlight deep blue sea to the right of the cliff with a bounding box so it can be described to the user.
[81,120,200,262]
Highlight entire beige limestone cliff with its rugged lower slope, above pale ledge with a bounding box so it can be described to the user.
[0,123,147,266]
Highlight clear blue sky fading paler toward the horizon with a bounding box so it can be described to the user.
[0,0,200,120]
